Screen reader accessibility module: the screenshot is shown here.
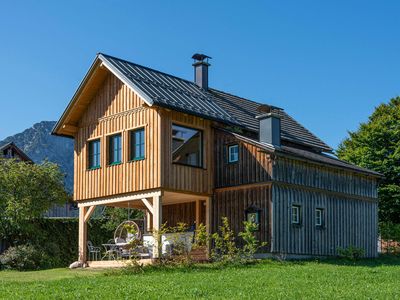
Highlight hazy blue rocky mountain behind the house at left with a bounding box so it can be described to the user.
[0,121,74,192]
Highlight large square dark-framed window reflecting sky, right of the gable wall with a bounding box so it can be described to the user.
[172,124,203,167]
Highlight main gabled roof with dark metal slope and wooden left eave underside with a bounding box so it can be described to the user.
[53,53,332,152]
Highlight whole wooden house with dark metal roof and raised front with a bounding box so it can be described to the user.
[53,53,380,262]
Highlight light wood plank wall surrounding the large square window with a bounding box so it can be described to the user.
[161,110,214,195]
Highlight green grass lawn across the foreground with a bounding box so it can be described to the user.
[0,257,400,299]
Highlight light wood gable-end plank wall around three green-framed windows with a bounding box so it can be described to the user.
[74,74,161,200]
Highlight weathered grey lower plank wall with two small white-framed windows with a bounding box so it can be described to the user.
[271,185,378,257]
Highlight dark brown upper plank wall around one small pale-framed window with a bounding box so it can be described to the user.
[214,129,272,188]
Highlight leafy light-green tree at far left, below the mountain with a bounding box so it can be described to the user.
[0,159,68,244]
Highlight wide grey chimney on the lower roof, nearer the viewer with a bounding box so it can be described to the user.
[256,112,281,147]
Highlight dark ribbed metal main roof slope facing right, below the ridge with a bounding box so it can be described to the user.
[98,53,332,152]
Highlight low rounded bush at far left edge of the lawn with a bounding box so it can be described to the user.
[0,244,49,271]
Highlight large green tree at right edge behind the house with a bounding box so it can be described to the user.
[337,97,400,223]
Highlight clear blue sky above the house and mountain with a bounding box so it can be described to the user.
[0,0,400,147]
